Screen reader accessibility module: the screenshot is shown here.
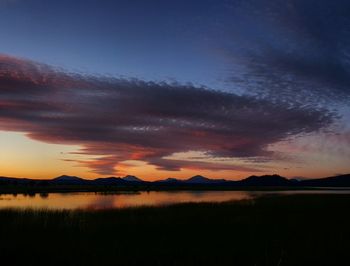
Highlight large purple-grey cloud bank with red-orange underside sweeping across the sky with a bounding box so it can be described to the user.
[0,55,334,174]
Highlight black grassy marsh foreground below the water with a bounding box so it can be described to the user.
[0,195,350,266]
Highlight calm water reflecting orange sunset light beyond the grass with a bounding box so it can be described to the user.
[0,190,350,209]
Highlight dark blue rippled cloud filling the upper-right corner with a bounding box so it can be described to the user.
[223,0,350,105]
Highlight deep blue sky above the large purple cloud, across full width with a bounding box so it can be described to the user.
[0,0,350,97]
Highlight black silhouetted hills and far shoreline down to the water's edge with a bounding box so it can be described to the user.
[0,174,350,191]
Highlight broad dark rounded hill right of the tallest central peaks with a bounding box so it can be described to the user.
[237,175,295,187]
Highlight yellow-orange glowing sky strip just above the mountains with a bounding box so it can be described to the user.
[0,131,346,181]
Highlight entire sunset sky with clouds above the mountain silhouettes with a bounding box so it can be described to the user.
[0,0,350,180]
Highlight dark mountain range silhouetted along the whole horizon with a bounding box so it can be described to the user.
[0,174,350,187]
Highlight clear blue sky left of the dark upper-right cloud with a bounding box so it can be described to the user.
[0,0,232,87]
